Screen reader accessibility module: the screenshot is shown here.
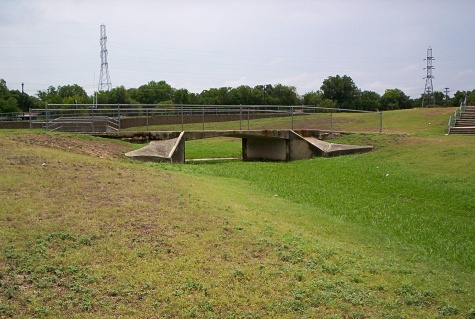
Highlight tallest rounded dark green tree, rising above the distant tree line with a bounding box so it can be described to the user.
[320,75,359,109]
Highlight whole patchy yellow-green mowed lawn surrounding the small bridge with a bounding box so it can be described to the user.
[0,109,475,318]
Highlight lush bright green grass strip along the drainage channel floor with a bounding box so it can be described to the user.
[173,136,475,269]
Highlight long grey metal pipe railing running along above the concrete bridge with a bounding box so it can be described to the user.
[25,104,382,133]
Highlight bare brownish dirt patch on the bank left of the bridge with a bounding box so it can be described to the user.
[10,134,130,158]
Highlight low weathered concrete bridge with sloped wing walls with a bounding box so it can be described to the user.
[100,130,373,164]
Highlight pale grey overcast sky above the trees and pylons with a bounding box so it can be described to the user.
[0,0,475,98]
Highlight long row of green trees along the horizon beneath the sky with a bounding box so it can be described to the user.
[0,75,475,113]
